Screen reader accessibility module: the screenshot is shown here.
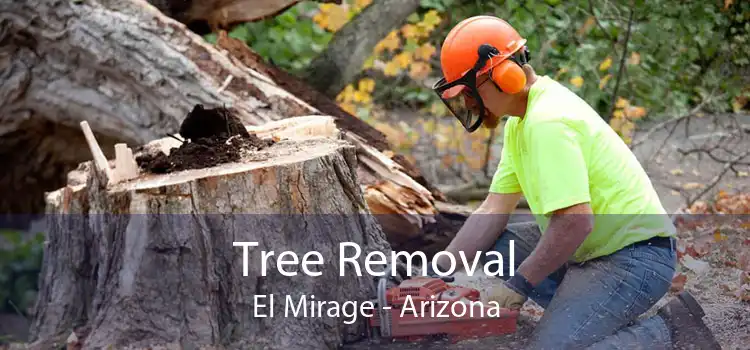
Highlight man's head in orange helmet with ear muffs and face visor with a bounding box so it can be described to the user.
[433,16,534,132]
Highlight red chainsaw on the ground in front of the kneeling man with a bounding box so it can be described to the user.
[368,277,519,343]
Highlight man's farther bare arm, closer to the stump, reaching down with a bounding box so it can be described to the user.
[437,192,521,271]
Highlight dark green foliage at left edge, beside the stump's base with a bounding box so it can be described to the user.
[0,230,44,314]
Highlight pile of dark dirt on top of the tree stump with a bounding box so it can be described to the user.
[136,104,274,174]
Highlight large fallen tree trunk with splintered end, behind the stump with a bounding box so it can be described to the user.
[0,0,464,254]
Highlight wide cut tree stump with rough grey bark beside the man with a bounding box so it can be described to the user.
[31,118,390,349]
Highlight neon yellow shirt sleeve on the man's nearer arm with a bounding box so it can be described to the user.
[528,121,591,215]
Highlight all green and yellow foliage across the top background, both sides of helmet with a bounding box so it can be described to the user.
[207,0,750,123]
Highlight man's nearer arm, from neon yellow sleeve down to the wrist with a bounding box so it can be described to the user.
[508,120,594,294]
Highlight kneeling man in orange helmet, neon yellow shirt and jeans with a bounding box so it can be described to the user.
[434,16,720,349]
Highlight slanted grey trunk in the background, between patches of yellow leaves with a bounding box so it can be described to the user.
[305,0,419,97]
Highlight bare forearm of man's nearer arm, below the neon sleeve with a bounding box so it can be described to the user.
[516,203,594,286]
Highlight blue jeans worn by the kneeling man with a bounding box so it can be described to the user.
[493,223,677,349]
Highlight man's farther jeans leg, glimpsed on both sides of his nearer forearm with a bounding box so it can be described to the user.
[484,223,565,308]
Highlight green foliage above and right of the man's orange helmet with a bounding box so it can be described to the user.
[434,0,750,117]
